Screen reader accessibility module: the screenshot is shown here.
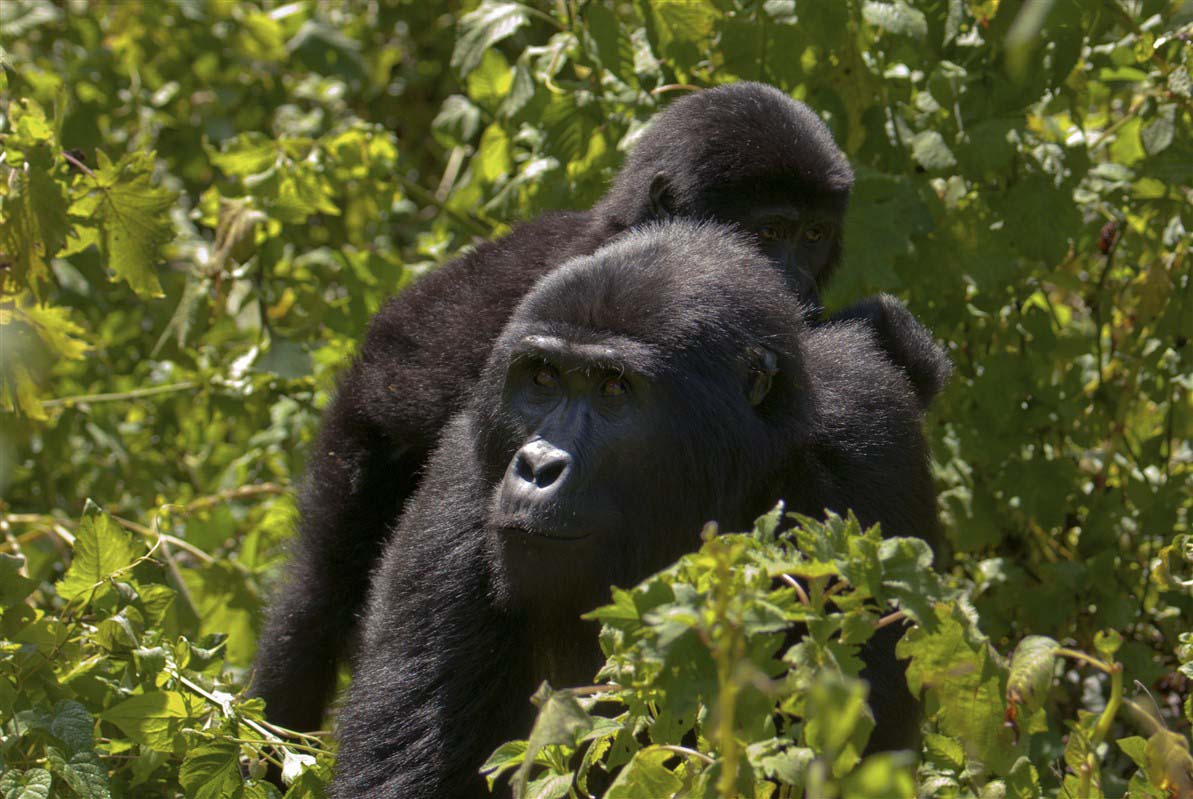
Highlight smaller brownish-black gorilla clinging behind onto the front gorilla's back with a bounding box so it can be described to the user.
[254,83,897,730]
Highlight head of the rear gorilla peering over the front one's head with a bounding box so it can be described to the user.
[594,82,853,304]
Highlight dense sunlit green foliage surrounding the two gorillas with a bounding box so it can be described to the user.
[0,0,1193,799]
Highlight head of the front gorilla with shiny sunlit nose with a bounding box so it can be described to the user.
[474,223,806,613]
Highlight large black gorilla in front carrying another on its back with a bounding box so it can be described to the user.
[335,222,947,799]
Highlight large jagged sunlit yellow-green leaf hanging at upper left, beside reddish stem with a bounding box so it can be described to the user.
[70,151,178,297]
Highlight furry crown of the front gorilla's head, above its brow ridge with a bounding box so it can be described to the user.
[505,222,803,355]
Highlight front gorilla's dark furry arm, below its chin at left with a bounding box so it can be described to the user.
[333,417,532,799]
